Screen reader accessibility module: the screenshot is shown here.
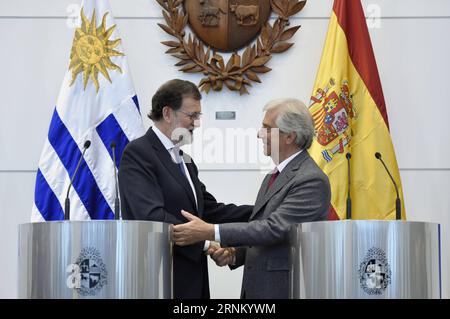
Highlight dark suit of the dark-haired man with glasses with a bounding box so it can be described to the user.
[119,128,253,298]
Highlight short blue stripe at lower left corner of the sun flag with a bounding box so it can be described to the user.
[34,169,64,221]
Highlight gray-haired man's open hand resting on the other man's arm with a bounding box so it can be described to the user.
[172,210,215,246]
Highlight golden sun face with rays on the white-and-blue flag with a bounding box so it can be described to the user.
[69,9,124,92]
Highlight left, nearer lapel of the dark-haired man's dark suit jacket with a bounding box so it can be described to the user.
[147,129,197,211]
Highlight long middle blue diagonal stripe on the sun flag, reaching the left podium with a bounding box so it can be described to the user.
[48,109,114,219]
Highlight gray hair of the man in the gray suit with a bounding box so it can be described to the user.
[264,98,315,149]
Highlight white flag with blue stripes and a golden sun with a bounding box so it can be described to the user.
[31,0,144,221]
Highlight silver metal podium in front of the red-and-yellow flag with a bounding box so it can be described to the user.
[290,220,441,299]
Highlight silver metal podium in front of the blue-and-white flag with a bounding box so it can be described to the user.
[18,220,172,299]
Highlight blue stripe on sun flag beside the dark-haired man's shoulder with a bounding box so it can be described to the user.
[96,114,129,167]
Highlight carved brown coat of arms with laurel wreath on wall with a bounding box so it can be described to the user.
[156,0,306,94]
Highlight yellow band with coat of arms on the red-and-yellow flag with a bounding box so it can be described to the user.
[309,0,405,220]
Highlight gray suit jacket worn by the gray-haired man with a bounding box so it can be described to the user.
[219,150,331,299]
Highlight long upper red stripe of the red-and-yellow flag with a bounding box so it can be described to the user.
[333,0,389,129]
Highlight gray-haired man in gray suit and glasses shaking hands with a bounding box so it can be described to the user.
[172,99,331,299]
